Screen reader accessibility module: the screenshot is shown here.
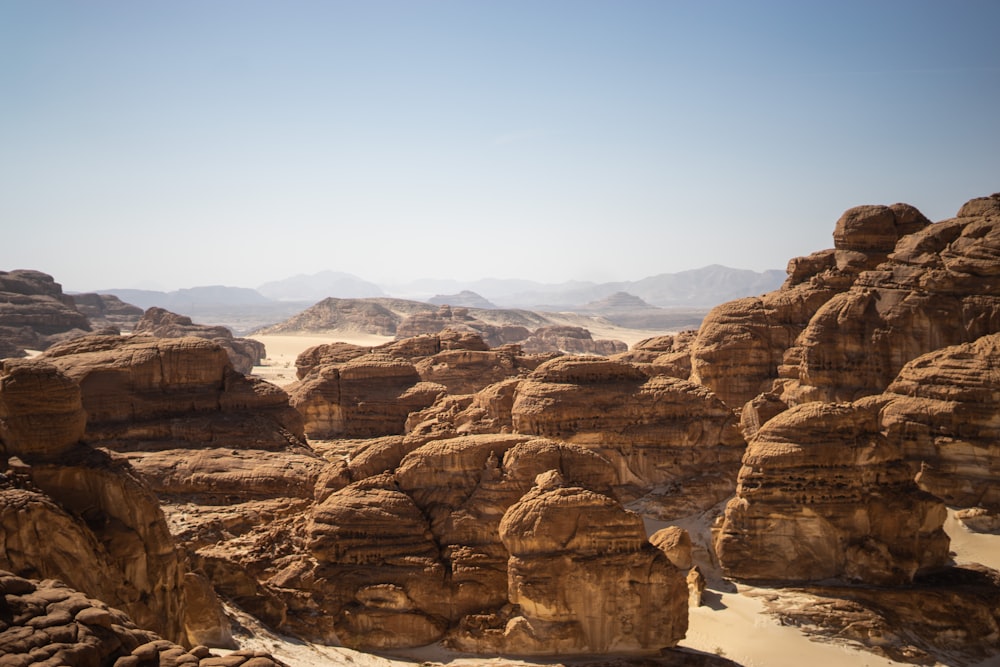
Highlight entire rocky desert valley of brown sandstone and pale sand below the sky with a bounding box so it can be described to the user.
[0,194,1000,667]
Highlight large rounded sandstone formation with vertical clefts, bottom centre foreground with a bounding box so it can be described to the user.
[300,434,688,653]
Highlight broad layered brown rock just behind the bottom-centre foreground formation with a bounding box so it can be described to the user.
[511,357,744,518]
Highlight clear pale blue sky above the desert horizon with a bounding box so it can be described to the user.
[0,0,1000,291]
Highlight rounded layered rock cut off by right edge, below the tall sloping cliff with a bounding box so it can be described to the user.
[880,334,1000,514]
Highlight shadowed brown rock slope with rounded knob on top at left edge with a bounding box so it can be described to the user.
[0,360,211,641]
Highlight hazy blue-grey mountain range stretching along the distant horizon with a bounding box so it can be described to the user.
[86,264,785,335]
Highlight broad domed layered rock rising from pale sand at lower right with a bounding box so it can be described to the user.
[715,398,949,585]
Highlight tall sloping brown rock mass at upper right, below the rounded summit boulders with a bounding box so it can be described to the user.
[775,194,1000,405]
